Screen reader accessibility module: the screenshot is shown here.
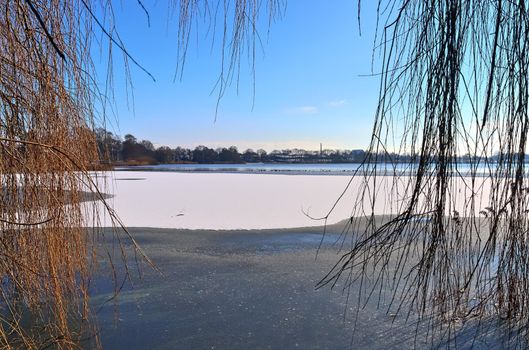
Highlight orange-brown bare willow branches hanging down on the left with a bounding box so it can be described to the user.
[0,0,153,349]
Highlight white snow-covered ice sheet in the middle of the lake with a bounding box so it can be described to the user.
[91,171,489,229]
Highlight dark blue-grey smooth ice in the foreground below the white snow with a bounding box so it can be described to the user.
[91,228,509,350]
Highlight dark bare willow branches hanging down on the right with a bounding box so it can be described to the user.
[320,0,529,344]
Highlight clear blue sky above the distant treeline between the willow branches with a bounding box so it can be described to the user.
[96,0,378,151]
